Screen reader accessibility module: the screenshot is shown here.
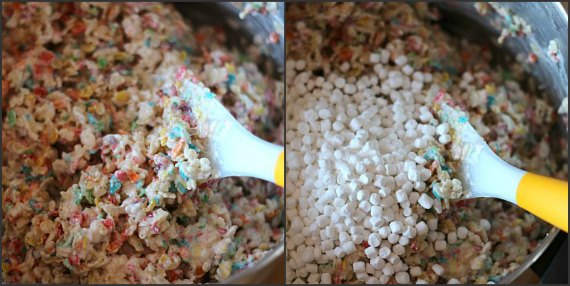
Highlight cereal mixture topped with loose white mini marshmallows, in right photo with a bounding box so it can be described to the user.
[285,3,568,284]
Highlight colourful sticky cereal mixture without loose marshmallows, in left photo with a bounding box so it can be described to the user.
[2,3,283,283]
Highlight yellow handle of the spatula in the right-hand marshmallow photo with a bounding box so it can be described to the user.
[517,173,568,232]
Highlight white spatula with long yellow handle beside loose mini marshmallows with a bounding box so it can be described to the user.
[435,100,568,232]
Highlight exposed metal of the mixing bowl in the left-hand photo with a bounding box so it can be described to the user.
[171,2,285,284]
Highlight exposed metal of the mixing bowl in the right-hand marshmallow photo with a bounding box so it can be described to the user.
[434,2,568,284]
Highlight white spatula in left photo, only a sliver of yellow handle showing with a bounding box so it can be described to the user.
[179,79,285,187]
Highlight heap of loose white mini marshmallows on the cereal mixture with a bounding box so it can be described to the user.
[286,50,467,283]
